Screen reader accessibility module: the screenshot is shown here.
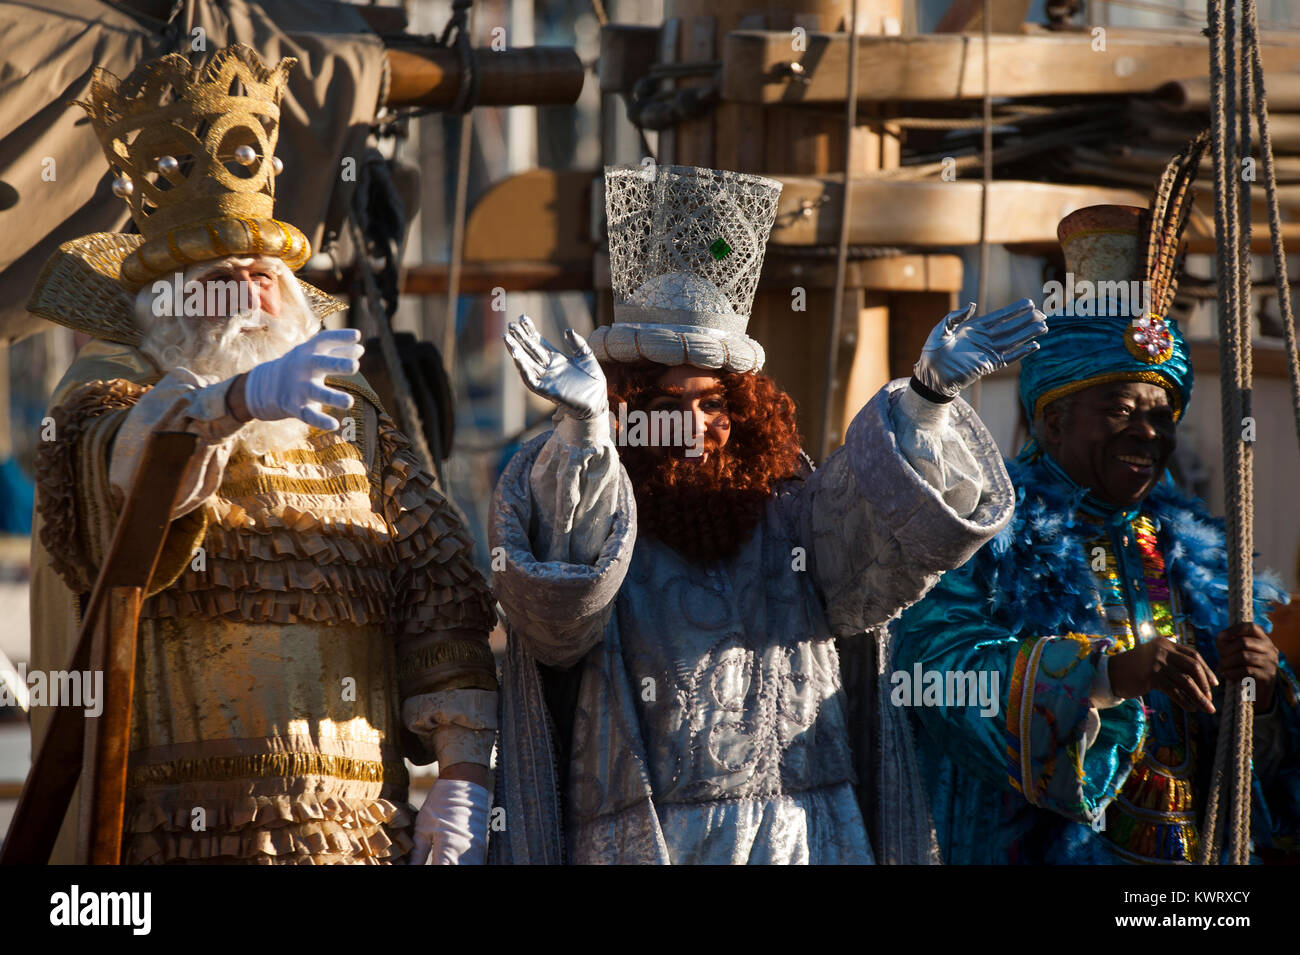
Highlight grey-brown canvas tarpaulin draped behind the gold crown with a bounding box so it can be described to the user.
[0,0,387,342]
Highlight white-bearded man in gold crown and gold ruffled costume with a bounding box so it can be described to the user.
[21,45,497,863]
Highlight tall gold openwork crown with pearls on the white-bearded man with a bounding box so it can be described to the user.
[77,44,311,291]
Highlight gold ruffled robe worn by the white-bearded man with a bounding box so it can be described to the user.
[33,342,495,863]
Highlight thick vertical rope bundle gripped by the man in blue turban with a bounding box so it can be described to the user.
[1200,0,1248,864]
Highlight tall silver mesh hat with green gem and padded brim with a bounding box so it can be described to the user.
[589,165,781,373]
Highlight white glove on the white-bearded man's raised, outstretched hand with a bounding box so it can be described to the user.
[244,329,365,431]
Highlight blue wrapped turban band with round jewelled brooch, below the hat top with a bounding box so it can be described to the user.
[1021,307,1192,422]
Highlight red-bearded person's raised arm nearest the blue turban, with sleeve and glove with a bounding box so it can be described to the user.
[801,299,1047,635]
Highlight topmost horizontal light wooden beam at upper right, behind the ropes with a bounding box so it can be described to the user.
[723,27,1300,103]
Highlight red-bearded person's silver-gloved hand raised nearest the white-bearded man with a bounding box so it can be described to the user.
[504,314,610,420]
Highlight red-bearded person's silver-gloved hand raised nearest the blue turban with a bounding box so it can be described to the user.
[913,299,1048,400]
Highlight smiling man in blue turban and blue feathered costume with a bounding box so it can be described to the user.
[892,207,1300,864]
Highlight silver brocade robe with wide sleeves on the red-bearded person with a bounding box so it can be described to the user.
[491,381,1013,864]
